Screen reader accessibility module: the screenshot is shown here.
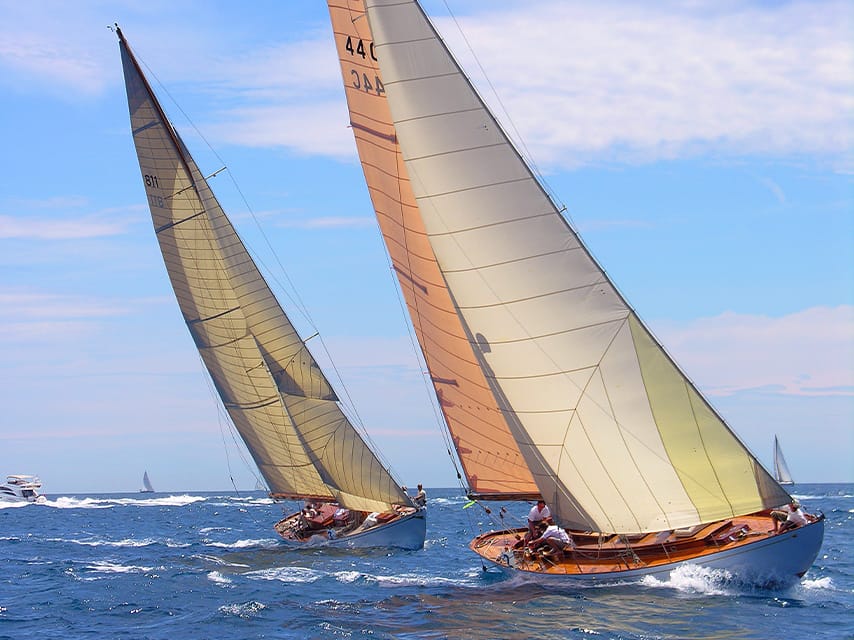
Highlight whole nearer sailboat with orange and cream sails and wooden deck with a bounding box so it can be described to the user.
[328,0,824,582]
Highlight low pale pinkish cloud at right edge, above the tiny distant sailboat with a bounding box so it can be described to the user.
[656,305,854,397]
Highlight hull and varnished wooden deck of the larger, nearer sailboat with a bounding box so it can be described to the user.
[470,514,824,585]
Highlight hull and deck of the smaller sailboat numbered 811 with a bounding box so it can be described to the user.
[275,509,427,550]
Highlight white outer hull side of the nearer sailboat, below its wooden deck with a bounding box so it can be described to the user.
[485,518,824,585]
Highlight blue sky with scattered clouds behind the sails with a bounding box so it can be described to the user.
[0,0,854,495]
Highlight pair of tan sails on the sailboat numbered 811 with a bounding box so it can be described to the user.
[119,27,409,511]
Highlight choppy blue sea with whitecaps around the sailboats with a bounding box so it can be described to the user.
[0,484,854,640]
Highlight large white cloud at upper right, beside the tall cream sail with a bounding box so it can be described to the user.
[440,1,854,165]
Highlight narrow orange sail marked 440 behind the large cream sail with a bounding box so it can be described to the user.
[329,0,539,499]
